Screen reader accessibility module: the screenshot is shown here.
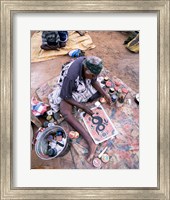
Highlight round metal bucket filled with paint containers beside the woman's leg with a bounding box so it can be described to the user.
[35,126,70,160]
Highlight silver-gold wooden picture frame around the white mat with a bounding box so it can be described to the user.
[0,0,170,200]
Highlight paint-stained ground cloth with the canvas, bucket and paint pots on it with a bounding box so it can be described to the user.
[31,69,139,169]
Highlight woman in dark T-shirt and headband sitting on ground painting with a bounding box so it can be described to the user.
[49,56,111,161]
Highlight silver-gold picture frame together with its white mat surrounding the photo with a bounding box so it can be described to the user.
[0,0,170,200]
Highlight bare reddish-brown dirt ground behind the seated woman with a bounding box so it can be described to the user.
[31,31,139,168]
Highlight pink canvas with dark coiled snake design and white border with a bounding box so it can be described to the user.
[81,102,118,144]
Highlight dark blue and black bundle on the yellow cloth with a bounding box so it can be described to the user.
[41,31,68,50]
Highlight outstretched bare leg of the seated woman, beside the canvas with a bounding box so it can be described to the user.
[60,100,97,161]
